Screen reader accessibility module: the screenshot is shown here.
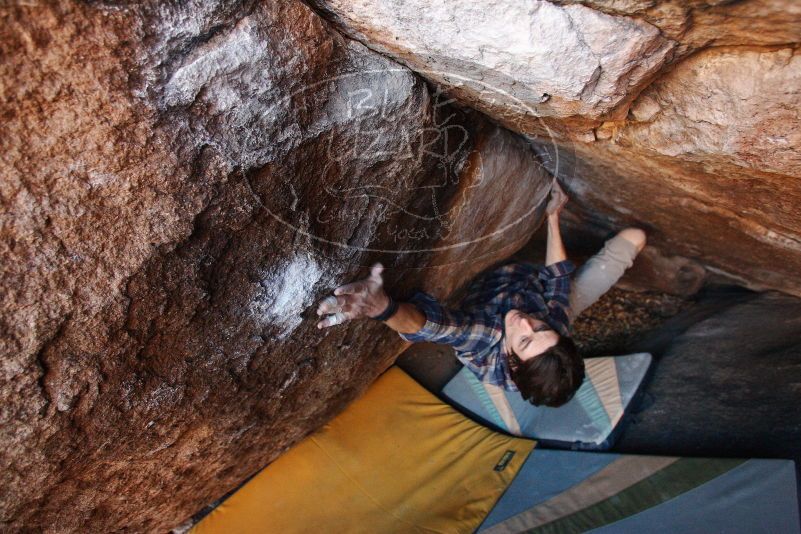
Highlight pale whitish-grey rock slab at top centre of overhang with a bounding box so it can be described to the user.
[310,0,676,128]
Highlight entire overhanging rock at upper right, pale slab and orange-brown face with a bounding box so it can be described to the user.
[315,0,801,295]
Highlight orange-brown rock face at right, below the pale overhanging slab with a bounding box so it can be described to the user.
[532,48,801,295]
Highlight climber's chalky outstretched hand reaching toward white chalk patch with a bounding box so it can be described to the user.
[317,263,389,328]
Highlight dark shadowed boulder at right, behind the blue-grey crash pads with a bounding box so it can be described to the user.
[616,288,801,474]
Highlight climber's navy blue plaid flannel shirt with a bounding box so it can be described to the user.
[399,260,575,391]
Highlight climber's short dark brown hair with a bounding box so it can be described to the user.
[509,336,584,407]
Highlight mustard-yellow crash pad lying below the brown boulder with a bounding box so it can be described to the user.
[193,367,534,534]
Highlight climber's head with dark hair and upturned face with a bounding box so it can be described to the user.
[504,310,584,407]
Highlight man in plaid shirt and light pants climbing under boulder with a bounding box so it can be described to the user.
[317,181,646,407]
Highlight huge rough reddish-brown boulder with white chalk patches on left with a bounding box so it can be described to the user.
[0,1,549,532]
